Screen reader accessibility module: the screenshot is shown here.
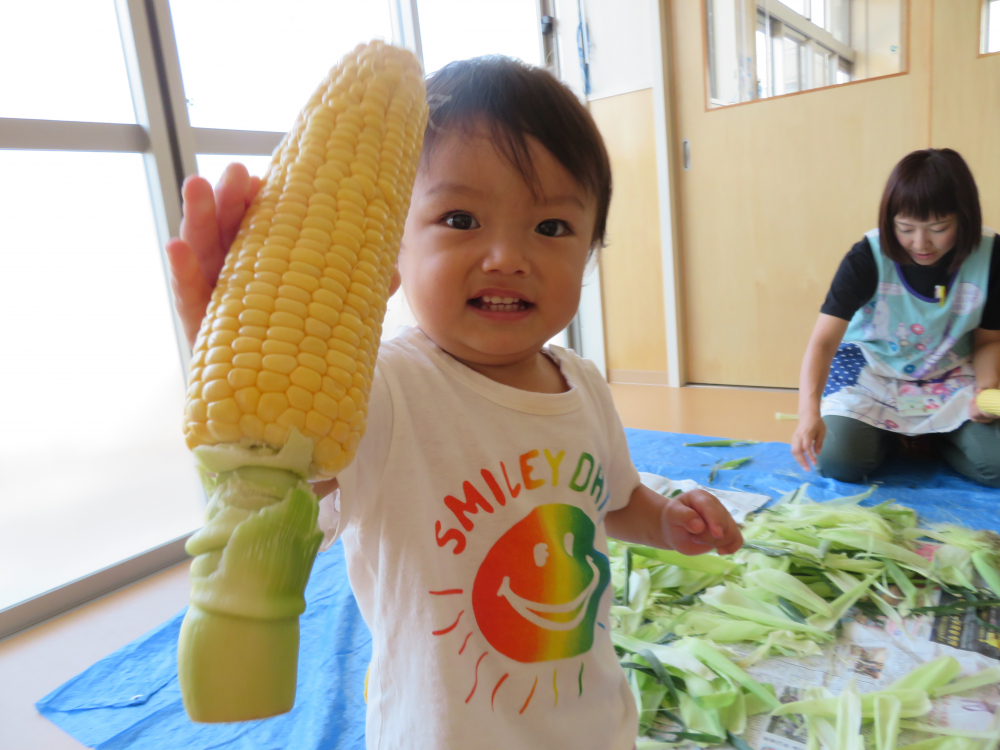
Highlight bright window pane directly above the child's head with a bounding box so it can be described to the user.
[417,0,541,73]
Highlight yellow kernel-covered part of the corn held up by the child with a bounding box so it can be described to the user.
[184,41,427,478]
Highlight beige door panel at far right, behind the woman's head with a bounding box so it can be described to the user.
[931,0,1000,230]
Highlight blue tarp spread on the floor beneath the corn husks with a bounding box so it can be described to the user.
[37,430,1000,750]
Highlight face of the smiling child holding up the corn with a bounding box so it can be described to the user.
[399,123,597,365]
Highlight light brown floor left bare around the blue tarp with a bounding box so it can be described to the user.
[0,384,797,750]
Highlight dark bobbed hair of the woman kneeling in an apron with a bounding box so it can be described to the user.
[878,148,983,271]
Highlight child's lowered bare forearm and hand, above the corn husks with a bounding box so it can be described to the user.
[604,484,743,555]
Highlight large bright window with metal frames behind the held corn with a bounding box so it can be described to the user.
[0,0,558,638]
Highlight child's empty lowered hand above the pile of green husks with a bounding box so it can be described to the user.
[660,490,743,555]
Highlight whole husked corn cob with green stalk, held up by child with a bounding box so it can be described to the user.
[178,41,427,721]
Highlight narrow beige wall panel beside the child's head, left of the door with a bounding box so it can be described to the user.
[590,89,667,372]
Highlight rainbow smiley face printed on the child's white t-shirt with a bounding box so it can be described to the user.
[472,503,611,663]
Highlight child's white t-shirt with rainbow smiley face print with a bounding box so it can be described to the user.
[321,329,639,750]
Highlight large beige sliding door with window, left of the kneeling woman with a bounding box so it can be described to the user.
[670,0,930,387]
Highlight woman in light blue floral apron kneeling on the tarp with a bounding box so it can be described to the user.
[792,149,1000,487]
